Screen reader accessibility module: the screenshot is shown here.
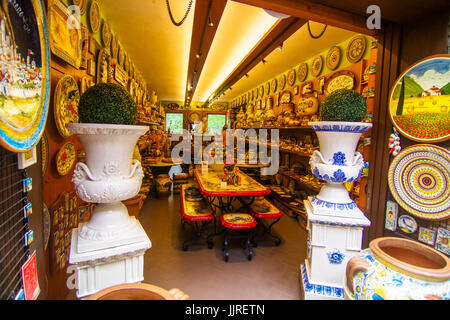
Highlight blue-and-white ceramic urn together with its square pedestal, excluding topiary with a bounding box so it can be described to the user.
[300,121,372,300]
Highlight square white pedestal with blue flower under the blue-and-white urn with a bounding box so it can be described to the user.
[301,197,370,300]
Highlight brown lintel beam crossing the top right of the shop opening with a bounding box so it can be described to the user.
[233,0,379,36]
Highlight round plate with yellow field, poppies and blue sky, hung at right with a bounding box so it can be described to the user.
[389,54,450,143]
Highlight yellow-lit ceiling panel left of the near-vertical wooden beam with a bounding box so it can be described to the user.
[99,0,195,100]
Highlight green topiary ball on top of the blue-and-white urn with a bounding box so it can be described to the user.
[319,89,367,122]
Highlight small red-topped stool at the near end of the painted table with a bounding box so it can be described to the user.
[220,213,257,261]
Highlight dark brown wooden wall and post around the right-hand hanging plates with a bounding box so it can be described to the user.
[363,12,450,247]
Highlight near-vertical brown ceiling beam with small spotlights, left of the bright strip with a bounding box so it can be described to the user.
[184,0,227,106]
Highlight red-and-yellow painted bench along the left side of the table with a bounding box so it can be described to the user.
[180,185,216,251]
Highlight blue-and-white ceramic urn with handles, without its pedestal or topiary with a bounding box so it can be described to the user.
[308,121,372,218]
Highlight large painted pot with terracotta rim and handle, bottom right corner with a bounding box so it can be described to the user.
[344,237,450,300]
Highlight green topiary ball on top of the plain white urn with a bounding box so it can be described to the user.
[78,83,138,125]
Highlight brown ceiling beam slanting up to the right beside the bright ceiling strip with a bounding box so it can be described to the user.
[203,17,307,107]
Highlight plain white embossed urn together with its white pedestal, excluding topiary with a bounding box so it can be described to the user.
[68,123,151,298]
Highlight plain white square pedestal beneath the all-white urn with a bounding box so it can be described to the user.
[69,220,151,298]
